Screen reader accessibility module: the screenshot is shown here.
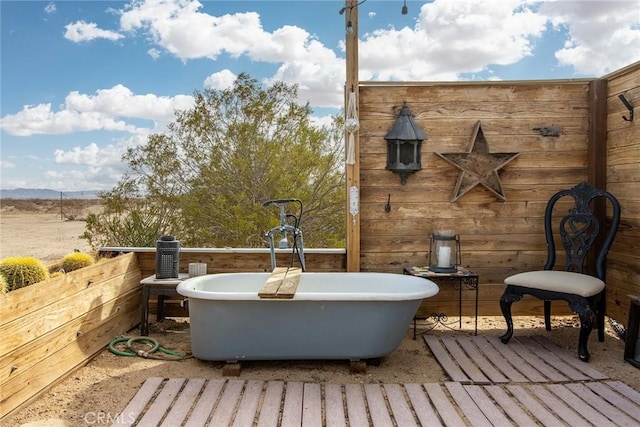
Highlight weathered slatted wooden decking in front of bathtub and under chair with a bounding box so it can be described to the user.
[114,336,640,427]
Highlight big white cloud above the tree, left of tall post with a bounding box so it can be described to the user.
[120,1,344,107]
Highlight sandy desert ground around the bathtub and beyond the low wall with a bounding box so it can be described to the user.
[0,201,640,427]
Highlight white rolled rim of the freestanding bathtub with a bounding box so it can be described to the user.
[176,272,440,302]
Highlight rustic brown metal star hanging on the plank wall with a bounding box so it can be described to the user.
[436,120,520,202]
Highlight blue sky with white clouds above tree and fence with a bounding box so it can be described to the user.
[0,0,640,191]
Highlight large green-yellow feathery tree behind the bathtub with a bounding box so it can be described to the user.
[88,74,345,247]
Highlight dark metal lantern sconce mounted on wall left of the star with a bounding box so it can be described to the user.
[384,101,427,185]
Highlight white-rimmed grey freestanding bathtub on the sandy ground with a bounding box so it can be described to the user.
[177,272,439,362]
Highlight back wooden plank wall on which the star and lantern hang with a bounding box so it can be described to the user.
[359,80,589,315]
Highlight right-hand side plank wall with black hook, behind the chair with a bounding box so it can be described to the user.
[605,63,640,324]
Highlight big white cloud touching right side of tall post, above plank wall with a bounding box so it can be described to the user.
[359,0,546,81]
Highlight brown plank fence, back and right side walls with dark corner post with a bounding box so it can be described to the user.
[356,62,640,322]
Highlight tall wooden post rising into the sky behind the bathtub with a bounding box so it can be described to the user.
[344,0,360,271]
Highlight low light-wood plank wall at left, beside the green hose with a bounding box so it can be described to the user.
[0,254,141,424]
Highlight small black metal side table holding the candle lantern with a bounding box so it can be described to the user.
[404,267,479,339]
